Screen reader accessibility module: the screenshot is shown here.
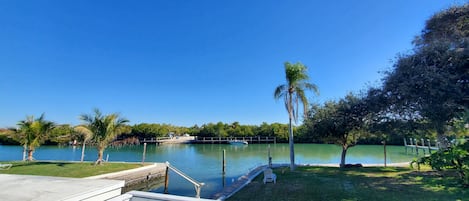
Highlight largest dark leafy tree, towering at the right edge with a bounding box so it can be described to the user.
[383,4,469,146]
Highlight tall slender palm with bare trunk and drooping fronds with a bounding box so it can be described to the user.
[274,62,319,171]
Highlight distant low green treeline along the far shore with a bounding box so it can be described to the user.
[0,122,422,145]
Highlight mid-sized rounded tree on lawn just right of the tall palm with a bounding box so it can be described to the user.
[304,94,368,167]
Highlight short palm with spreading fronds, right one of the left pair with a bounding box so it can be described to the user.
[75,109,129,165]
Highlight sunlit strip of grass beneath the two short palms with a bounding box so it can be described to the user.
[0,162,142,178]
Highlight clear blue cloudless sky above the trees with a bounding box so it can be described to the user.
[0,0,464,127]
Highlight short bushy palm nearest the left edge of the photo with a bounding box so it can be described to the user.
[13,114,55,161]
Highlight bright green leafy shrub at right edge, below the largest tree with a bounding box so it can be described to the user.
[412,142,469,187]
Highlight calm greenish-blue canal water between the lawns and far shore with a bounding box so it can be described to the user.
[0,144,415,197]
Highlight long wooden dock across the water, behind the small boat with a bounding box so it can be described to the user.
[192,136,277,144]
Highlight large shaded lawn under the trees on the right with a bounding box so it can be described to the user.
[227,167,469,201]
